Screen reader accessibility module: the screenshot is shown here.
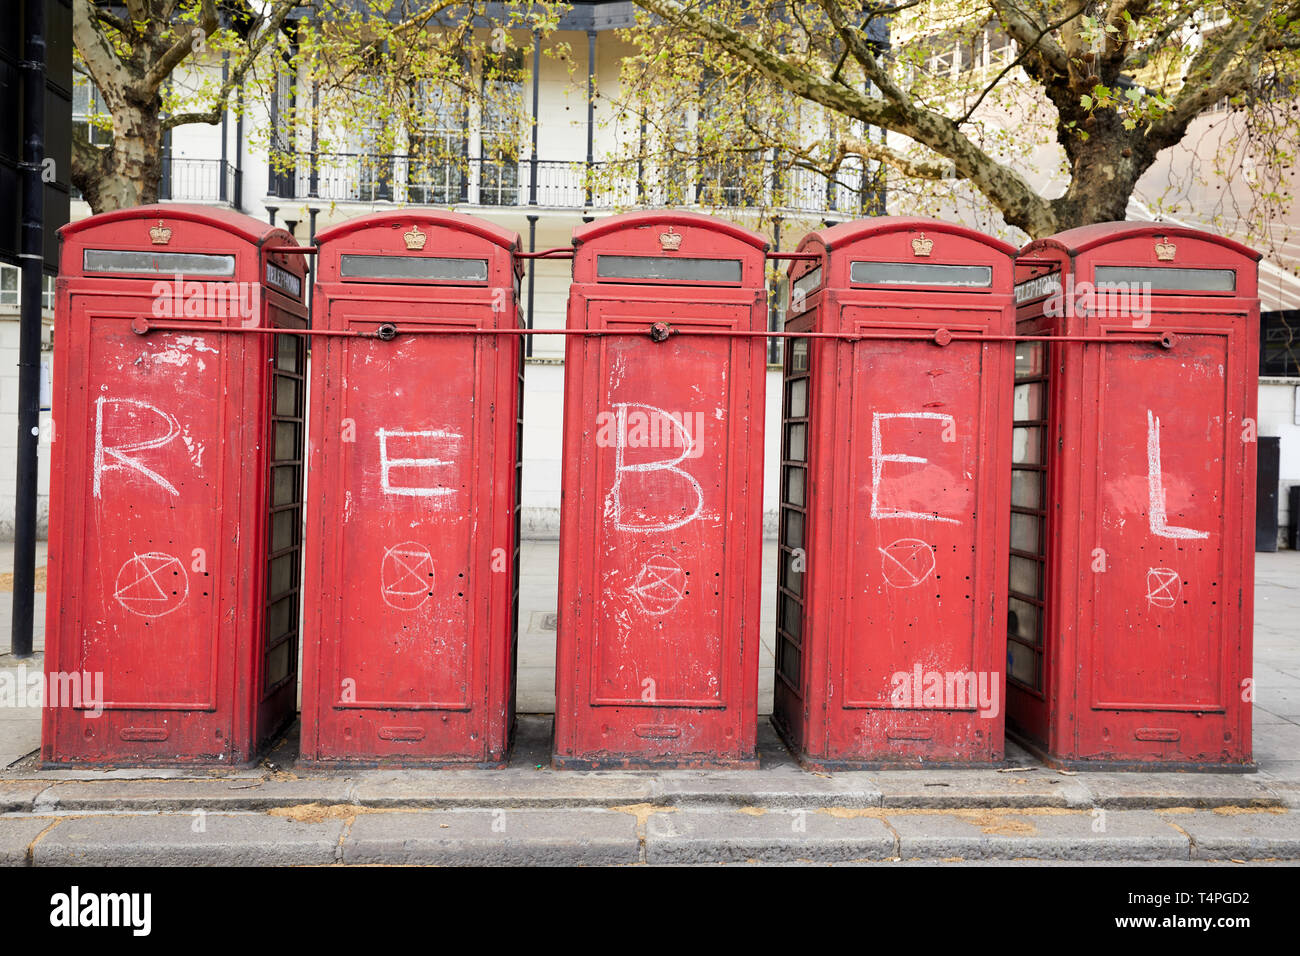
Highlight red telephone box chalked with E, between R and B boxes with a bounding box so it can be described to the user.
[302,209,524,765]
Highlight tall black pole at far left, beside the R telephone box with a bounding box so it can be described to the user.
[9,0,46,657]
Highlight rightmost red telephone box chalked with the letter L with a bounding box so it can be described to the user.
[1008,222,1260,769]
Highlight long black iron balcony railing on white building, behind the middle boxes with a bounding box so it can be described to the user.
[272,152,883,216]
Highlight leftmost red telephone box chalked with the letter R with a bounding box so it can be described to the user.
[42,206,307,765]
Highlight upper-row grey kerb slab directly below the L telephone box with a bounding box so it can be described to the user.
[1076,770,1282,809]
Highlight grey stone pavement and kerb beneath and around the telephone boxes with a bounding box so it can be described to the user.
[0,541,1300,865]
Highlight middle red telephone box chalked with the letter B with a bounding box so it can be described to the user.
[554,211,767,767]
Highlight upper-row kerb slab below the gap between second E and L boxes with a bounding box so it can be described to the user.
[871,763,1091,808]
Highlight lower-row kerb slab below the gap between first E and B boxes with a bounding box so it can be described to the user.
[342,810,641,866]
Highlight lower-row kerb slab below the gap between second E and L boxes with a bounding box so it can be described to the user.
[885,809,1190,861]
